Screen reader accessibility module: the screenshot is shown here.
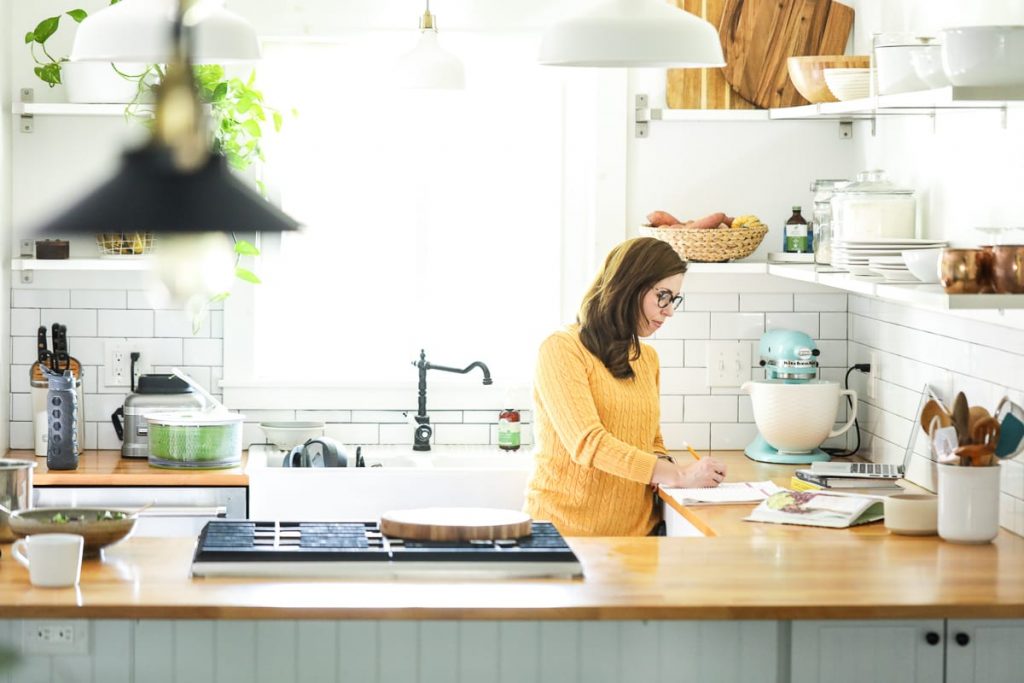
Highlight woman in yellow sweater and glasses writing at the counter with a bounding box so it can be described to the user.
[526,238,725,536]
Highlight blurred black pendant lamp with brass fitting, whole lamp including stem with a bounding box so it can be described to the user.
[37,0,299,236]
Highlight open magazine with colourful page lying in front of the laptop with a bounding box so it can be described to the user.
[746,490,885,528]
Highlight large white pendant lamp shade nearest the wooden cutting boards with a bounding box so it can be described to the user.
[540,0,725,68]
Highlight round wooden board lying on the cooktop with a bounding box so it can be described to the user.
[381,508,531,541]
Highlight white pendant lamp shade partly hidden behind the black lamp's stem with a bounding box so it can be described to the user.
[71,0,260,63]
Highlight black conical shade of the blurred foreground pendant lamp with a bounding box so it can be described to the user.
[37,144,299,234]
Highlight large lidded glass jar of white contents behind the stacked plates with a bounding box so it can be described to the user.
[831,170,918,242]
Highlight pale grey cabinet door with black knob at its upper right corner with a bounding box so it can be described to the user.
[791,620,945,683]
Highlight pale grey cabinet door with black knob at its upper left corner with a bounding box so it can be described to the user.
[946,620,1024,683]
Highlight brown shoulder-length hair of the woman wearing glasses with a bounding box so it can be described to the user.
[577,238,686,379]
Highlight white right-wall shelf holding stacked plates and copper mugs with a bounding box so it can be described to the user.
[768,263,1024,310]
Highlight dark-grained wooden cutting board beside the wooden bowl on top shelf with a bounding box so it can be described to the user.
[718,0,854,109]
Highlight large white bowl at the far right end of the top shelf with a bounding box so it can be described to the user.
[937,26,1024,87]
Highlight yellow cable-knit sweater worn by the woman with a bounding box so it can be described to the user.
[526,326,667,536]
